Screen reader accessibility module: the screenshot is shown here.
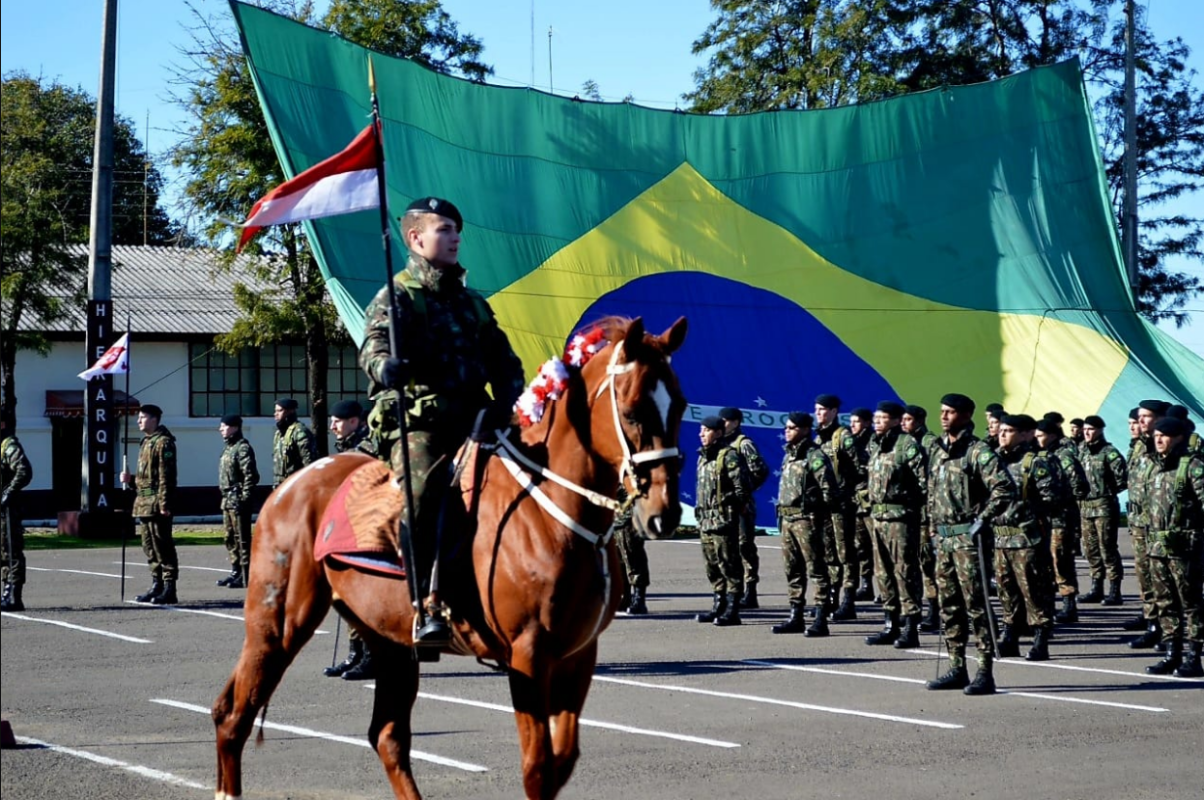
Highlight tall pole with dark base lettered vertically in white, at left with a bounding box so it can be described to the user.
[79,0,117,535]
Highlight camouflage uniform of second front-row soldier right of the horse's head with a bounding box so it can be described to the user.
[778,439,840,606]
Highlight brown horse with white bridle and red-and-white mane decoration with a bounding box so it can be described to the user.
[213,318,686,800]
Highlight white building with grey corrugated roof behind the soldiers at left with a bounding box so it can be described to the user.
[14,246,367,519]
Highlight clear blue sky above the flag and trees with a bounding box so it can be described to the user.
[0,0,1204,355]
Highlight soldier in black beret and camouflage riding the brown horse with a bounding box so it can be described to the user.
[359,198,524,646]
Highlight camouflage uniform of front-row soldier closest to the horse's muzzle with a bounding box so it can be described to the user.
[694,445,753,595]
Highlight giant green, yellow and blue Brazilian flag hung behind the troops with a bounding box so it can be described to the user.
[232,2,1204,522]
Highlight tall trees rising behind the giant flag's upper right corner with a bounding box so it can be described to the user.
[685,0,1204,324]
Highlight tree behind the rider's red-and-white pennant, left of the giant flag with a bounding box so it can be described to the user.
[172,0,492,454]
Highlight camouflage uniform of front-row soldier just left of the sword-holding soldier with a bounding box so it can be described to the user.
[868,427,928,619]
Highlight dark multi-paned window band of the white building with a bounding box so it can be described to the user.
[189,343,368,417]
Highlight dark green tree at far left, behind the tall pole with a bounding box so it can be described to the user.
[0,72,179,407]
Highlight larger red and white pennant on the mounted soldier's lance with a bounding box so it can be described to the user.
[238,125,380,251]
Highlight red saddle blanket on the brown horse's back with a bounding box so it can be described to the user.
[313,461,406,577]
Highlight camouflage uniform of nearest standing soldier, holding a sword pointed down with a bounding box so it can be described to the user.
[928,429,1016,667]
